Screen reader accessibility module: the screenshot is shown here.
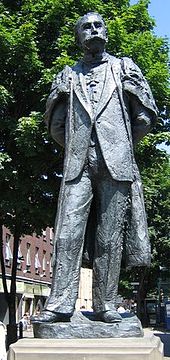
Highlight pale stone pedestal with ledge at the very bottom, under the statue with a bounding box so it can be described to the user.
[8,333,163,360]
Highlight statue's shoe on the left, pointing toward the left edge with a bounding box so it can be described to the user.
[30,310,72,324]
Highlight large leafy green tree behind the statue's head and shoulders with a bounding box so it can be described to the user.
[0,0,170,340]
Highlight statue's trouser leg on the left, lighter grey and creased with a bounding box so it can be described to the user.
[45,172,92,313]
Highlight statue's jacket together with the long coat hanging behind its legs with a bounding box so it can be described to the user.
[45,55,157,267]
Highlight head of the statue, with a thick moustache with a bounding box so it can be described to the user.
[75,12,107,50]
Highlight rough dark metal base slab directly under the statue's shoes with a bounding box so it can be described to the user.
[33,312,144,339]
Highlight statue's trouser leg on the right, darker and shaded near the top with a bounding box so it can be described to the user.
[93,174,130,312]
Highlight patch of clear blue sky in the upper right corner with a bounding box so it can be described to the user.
[130,0,170,38]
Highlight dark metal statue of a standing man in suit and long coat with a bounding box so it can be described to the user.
[33,12,157,323]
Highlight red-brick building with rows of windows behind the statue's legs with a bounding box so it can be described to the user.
[0,227,92,323]
